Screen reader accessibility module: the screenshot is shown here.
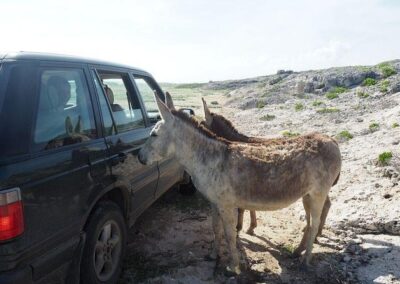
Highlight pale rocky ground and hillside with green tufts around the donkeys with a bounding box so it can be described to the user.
[121,61,400,283]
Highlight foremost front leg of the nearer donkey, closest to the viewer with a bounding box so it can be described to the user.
[219,208,240,274]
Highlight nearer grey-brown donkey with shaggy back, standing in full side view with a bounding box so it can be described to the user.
[138,96,341,274]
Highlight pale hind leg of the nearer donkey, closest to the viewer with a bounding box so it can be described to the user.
[304,190,328,266]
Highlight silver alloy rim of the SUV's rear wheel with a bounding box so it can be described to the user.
[93,220,122,281]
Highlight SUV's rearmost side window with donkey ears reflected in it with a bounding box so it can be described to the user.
[33,68,97,151]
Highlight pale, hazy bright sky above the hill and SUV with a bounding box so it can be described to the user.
[0,0,400,83]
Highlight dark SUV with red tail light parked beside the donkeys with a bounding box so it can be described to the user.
[0,52,184,284]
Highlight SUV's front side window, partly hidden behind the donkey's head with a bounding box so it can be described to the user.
[133,74,161,122]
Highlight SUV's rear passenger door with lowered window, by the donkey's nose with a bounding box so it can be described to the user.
[92,66,159,224]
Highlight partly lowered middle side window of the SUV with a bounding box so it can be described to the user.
[97,70,145,133]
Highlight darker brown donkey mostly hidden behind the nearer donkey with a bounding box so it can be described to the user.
[199,97,339,240]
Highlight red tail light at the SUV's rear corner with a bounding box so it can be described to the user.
[0,188,24,241]
